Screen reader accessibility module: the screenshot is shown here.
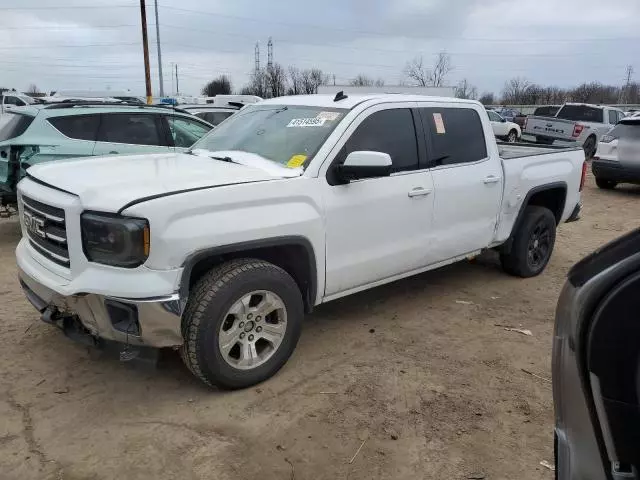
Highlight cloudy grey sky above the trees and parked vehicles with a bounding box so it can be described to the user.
[0,0,640,95]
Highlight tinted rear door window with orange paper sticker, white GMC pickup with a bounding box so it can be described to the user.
[420,108,488,166]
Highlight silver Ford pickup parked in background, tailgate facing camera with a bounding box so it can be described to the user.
[524,103,625,158]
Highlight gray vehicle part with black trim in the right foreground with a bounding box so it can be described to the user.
[552,229,640,480]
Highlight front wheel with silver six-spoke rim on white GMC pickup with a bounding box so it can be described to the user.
[181,259,304,389]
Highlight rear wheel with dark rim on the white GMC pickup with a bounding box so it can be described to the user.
[500,206,556,278]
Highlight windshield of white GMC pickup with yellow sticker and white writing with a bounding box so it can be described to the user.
[192,104,348,168]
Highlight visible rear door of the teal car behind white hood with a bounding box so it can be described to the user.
[93,112,173,155]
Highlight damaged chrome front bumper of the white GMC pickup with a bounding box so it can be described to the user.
[16,240,184,348]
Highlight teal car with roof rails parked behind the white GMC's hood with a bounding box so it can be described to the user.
[0,102,213,203]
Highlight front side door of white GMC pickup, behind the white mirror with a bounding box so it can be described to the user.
[323,103,434,297]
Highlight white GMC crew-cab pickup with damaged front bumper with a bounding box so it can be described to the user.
[16,92,585,388]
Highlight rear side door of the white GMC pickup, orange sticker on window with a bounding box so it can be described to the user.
[419,104,503,261]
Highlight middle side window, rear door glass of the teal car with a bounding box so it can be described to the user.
[98,113,166,145]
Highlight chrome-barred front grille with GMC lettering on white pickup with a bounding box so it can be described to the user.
[22,195,69,268]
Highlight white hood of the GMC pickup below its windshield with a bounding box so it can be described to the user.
[27,151,302,211]
